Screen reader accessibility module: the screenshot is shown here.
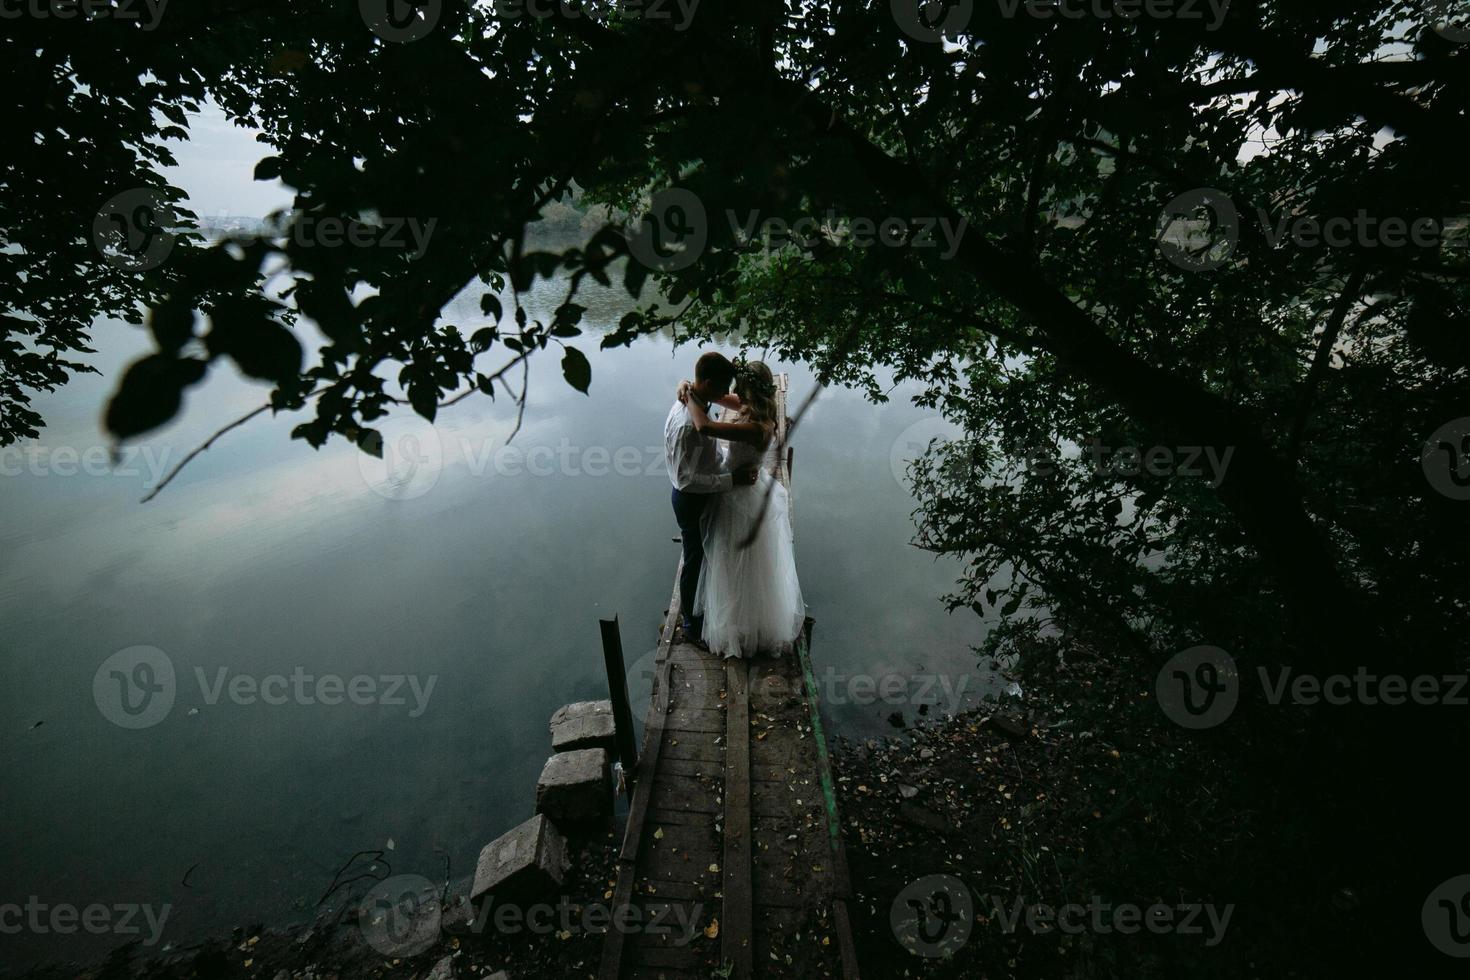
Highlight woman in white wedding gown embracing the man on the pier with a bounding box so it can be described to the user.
[679,361,807,657]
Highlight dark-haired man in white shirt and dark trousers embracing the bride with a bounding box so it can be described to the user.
[663,351,757,645]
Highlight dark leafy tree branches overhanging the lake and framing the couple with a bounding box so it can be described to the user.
[0,0,1470,975]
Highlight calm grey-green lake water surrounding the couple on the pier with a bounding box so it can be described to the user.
[0,262,1005,968]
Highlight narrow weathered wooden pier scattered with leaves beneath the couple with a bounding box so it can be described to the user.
[598,375,858,980]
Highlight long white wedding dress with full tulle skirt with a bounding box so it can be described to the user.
[694,442,807,657]
